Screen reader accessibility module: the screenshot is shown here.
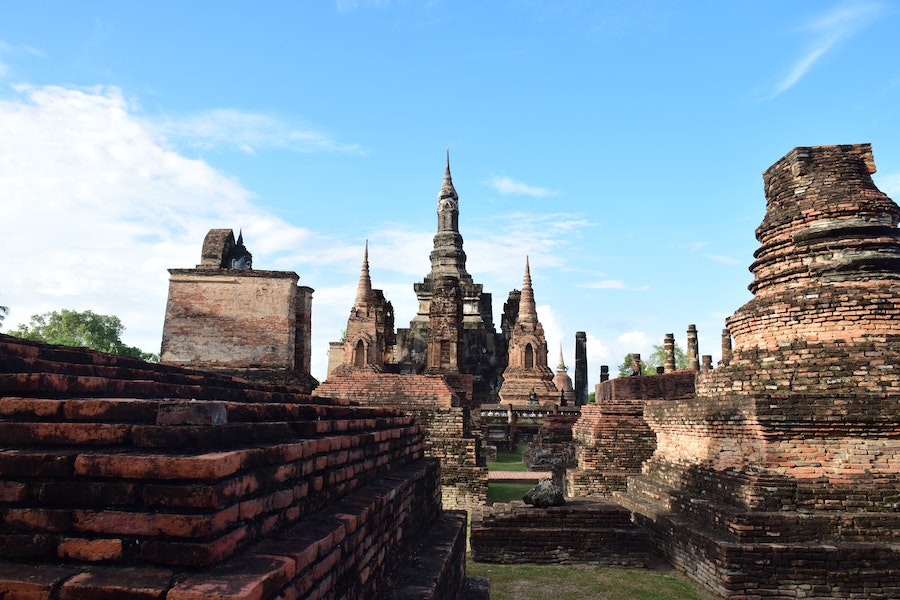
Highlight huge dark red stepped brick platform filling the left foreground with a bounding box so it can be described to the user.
[0,336,474,600]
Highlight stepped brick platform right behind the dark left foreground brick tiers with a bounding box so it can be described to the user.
[315,372,488,507]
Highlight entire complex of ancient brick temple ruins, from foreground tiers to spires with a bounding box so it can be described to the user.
[0,144,900,600]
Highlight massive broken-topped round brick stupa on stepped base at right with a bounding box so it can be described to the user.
[618,144,900,598]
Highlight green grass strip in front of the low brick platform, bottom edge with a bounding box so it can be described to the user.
[466,560,716,600]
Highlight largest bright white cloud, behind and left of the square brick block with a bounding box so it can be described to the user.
[0,86,338,370]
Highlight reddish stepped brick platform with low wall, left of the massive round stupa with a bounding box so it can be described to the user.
[566,370,697,496]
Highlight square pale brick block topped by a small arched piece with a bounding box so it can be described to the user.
[160,229,318,391]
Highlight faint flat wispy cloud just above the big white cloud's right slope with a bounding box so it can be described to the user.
[157,108,367,154]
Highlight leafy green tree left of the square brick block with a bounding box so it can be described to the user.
[9,309,159,362]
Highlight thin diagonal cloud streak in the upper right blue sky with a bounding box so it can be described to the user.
[763,2,884,100]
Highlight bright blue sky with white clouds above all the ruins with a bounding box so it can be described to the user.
[0,0,900,384]
